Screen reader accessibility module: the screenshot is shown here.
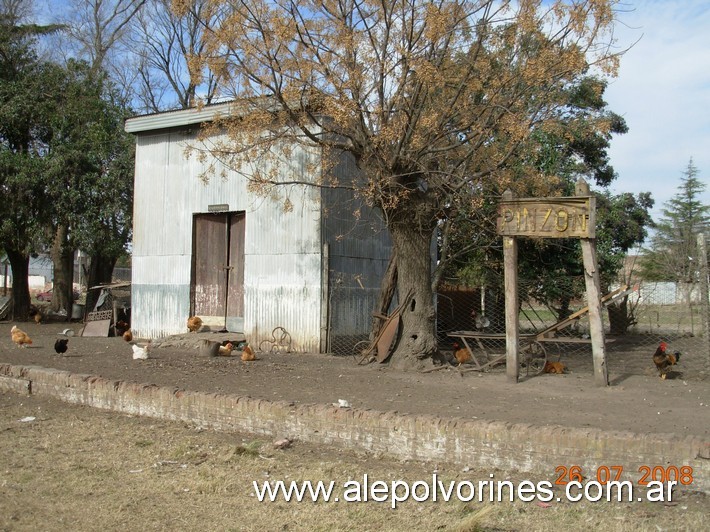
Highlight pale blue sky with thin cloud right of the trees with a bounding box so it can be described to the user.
[605,0,710,218]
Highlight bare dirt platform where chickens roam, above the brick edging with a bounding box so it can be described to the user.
[0,322,710,440]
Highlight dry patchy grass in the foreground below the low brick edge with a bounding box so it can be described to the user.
[0,393,710,532]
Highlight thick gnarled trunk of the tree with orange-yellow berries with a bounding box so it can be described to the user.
[390,223,436,370]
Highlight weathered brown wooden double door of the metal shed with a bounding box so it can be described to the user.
[191,213,245,332]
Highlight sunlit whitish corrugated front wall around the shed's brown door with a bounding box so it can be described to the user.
[132,131,321,351]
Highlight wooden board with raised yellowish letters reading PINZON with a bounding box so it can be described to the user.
[497,196,595,238]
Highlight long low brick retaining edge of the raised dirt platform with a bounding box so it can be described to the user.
[0,364,710,492]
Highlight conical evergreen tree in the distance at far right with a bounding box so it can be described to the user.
[641,158,710,284]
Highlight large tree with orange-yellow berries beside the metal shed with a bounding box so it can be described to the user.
[175,0,618,367]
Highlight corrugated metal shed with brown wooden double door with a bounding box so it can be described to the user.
[126,103,391,352]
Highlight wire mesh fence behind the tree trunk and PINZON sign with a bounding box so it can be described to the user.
[328,270,710,378]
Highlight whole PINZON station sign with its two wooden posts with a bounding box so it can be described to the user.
[497,179,609,386]
